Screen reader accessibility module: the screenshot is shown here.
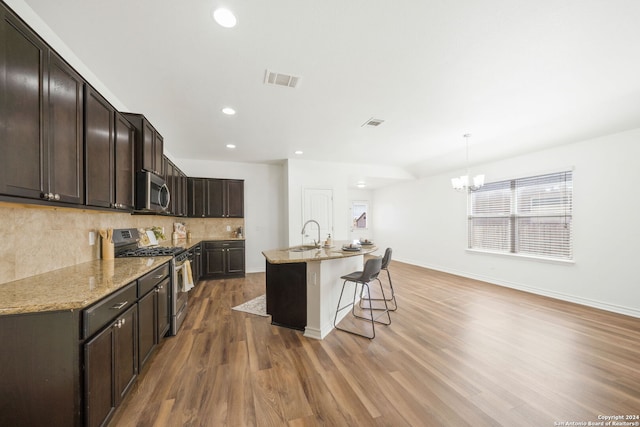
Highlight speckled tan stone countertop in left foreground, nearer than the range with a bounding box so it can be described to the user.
[0,256,171,316]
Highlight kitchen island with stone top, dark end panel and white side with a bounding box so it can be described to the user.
[262,241,378,339]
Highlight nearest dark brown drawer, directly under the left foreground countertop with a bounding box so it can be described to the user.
[82,281,137,338]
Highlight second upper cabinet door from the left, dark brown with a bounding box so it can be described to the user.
[47,52,84,204]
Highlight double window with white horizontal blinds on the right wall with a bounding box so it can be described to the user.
[469,171,573,260]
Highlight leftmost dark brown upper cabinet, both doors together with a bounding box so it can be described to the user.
[0,4,84,204]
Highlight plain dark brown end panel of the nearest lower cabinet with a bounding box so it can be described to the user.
[0,310,83,427]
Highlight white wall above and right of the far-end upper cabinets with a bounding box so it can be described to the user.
[176,159,287,273]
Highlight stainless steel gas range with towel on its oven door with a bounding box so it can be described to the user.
[113,228,193,335]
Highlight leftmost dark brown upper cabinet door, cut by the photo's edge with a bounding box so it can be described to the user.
[0,4,48,199]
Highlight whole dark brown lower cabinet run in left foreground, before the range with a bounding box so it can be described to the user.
[0,263,171,427]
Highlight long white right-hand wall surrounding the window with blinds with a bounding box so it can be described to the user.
[372,129,640,317]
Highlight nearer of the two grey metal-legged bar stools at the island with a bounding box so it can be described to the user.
[333,258,391,339]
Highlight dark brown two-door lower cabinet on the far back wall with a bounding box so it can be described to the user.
[202,240,245,279]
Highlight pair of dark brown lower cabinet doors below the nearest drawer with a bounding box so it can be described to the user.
[84,304,138,426]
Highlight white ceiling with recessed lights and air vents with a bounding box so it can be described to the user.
[18,0,640,184]
